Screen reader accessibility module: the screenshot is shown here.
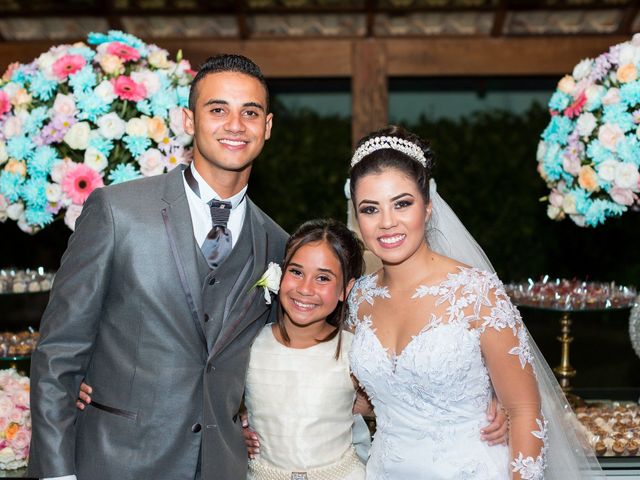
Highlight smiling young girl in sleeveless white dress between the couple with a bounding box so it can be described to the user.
[78,220,366,480]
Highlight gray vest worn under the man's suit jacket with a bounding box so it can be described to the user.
[195,206,253,351]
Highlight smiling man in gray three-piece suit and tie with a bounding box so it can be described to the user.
[29,55,287,480]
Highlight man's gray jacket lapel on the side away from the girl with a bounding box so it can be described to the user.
[160,166,206,345]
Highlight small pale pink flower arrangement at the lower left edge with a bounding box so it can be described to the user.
[0,369,31,470]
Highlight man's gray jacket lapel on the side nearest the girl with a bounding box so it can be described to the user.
[211,199,269,356]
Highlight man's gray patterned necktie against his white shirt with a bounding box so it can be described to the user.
[184,166,233,269]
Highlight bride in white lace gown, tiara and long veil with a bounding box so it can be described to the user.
[349,127,604,480]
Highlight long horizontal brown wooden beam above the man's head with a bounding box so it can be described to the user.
[0,36,628,78]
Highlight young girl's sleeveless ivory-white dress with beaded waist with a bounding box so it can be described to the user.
[245,325,364,480]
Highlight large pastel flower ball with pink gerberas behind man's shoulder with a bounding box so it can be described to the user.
[0,31,195,233]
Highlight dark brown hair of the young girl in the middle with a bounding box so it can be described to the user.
[276,219,364,359]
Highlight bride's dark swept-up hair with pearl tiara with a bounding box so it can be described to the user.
[349,125,435,206]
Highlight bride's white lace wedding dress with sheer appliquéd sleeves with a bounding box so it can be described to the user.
[349,267,546,479]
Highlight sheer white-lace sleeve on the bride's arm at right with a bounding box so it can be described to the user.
[479,276,547,480]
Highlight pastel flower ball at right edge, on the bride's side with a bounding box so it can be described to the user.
[537,34,640,227]
